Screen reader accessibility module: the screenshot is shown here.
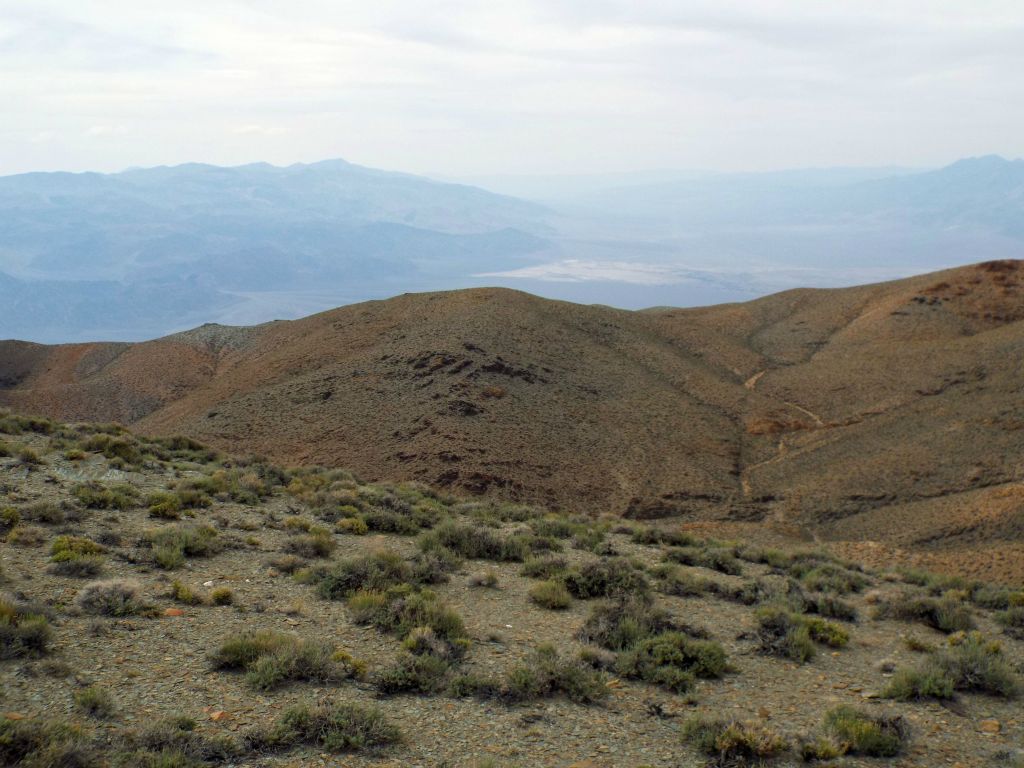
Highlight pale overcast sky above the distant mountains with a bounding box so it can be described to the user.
[0,0,1024,176]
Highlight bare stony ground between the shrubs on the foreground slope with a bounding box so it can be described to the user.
[0,419,1024,767]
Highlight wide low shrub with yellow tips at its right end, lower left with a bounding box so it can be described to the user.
[210,630,366,690]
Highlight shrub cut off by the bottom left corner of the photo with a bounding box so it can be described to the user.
[0,719,103,768]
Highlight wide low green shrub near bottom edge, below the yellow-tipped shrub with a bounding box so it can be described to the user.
[246,703,401,753]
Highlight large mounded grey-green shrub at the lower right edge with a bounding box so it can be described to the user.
[885,632,1020,700]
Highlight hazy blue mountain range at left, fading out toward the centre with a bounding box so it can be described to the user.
[0,161,551,339]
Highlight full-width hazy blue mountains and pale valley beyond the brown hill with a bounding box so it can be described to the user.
[0,157,1024,341]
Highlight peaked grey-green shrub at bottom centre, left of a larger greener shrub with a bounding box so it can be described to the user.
[503,644,608,703]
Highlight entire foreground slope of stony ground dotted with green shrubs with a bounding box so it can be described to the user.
[0,423,1024,768]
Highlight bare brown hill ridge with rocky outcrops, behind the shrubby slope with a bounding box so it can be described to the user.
[0,261,1024,579]
